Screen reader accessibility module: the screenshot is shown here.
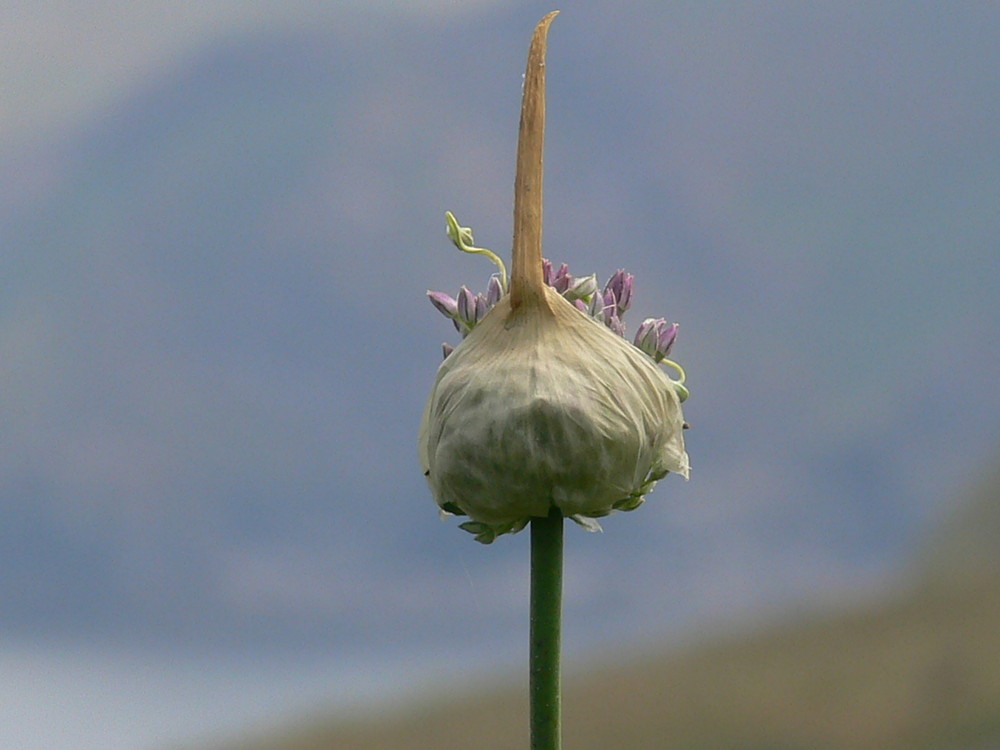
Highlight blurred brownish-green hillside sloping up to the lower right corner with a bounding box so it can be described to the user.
[209,452,1000,750]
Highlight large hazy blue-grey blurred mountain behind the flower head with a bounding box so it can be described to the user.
[0,2,1000,664]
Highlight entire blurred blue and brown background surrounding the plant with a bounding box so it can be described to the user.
[0,0,1000,750]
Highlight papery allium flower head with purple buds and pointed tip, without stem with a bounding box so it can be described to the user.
[419,10,688,543]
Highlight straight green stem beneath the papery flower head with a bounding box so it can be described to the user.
[529,508,563,750]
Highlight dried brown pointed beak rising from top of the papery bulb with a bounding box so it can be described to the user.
[510,10,559,309]
